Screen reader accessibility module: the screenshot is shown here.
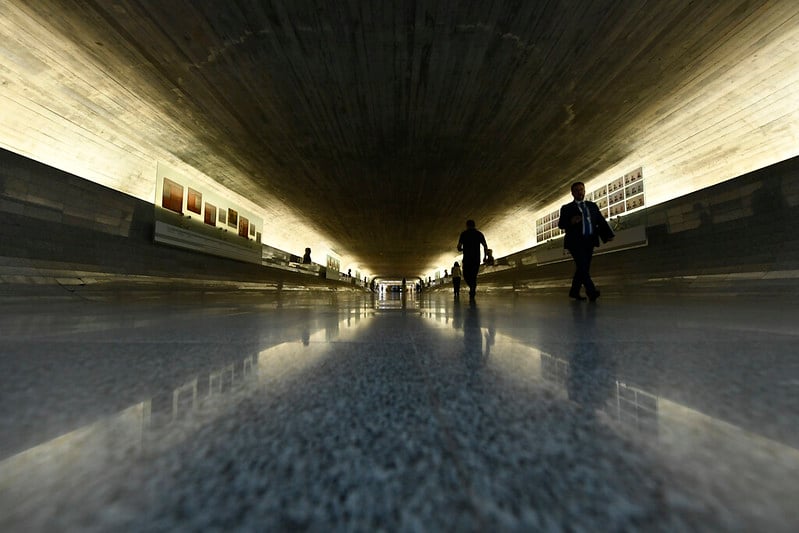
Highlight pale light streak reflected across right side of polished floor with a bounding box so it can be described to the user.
[422,302,799,523]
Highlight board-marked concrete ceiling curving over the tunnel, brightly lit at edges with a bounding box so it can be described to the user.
[0,0,799,277]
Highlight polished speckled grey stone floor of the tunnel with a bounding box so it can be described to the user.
[0,291,799,532]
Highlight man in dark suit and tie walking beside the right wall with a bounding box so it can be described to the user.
[558,181,615,302]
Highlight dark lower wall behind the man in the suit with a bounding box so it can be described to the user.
[476,157,799,295]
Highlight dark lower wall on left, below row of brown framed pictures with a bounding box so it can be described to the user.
[0,150,356,292]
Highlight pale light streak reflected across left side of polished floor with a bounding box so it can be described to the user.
[0,306,373,526]
